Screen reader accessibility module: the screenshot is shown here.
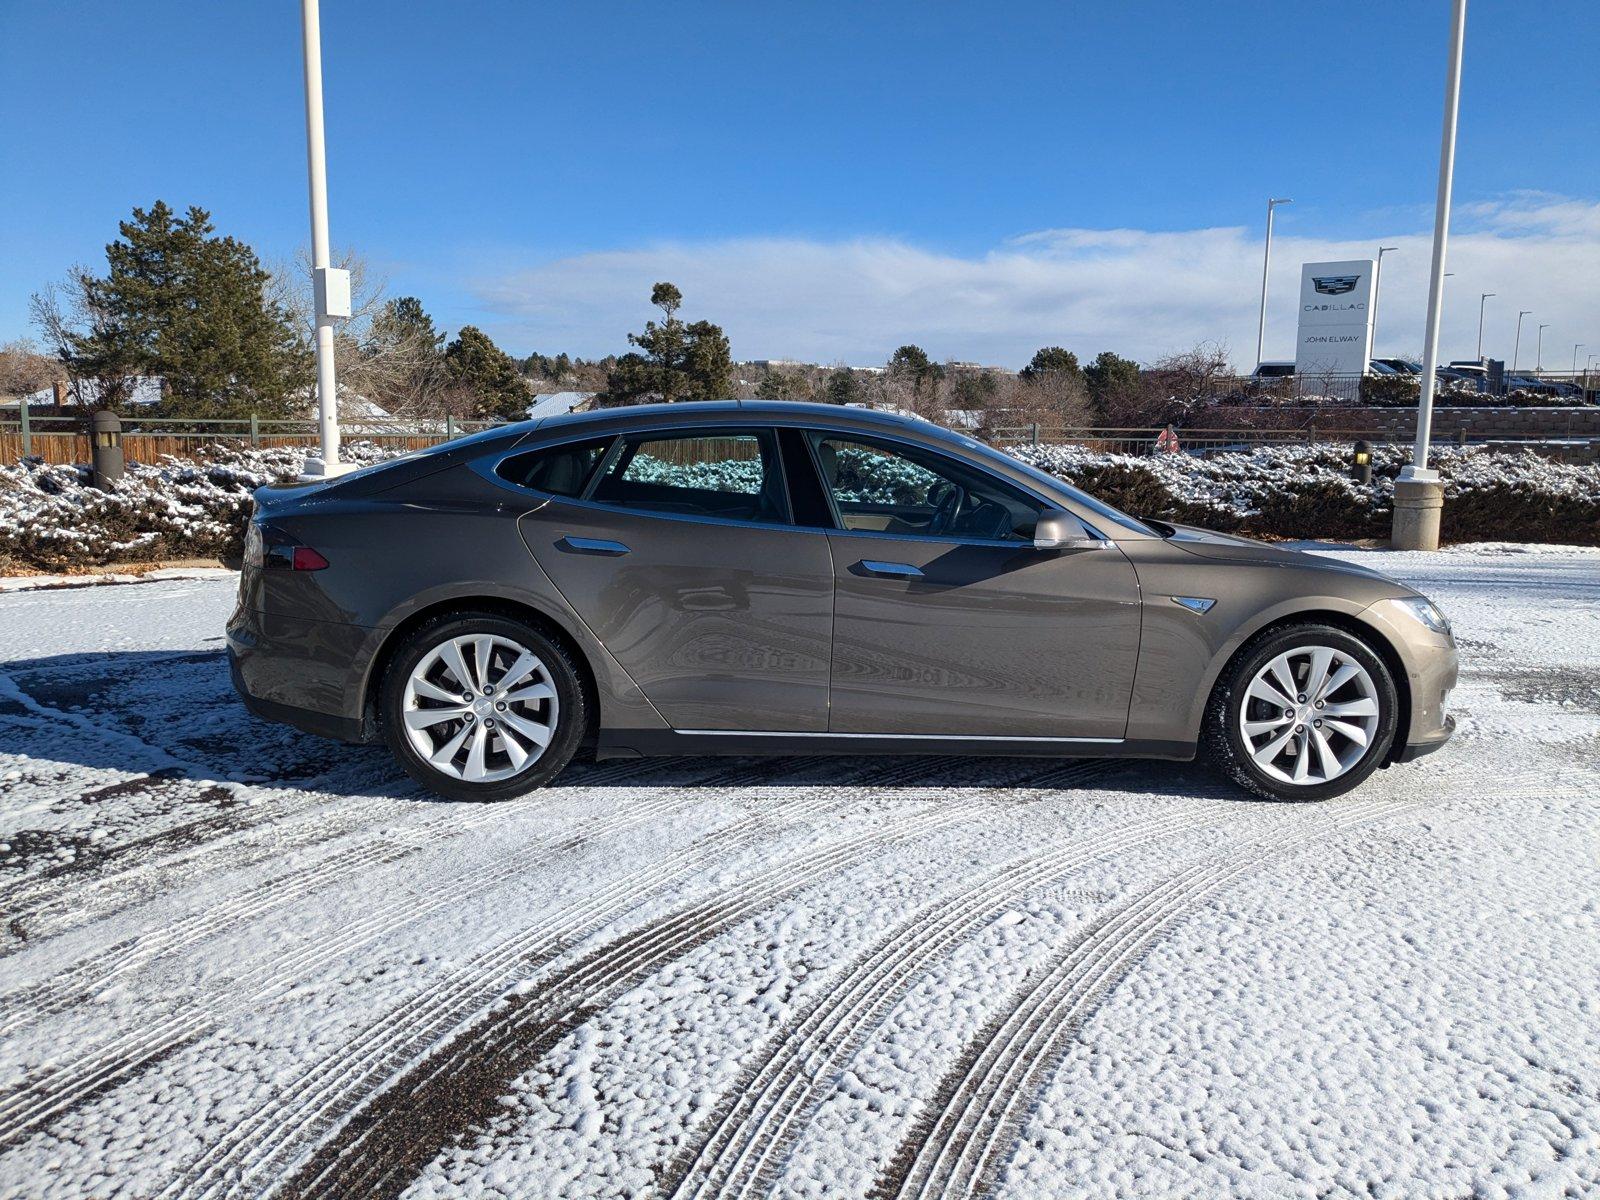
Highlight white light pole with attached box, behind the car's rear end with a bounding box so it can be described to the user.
[301,0,350,478]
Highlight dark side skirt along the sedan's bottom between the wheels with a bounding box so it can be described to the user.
[595,730,1195,762]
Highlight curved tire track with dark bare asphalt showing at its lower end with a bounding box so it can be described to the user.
[275,794,989,1198]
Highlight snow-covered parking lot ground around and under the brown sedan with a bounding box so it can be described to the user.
[0,547,1600,1200]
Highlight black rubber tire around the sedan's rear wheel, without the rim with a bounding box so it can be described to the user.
[378,611,589,802]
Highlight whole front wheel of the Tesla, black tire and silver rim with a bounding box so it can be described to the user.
[1202,624,1398,800]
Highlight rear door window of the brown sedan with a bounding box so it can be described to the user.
[590,430,789,525]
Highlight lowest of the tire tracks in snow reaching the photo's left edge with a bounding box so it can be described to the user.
[0,760,825,1147]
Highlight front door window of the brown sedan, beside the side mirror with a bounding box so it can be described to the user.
[811,434,1045,542]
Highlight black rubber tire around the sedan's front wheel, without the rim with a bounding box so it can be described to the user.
[1200,622,1400,802]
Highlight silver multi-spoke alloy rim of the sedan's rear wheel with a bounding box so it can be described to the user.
[402,634,560,784]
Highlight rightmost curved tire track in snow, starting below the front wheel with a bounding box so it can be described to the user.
[872,800,1414,1200]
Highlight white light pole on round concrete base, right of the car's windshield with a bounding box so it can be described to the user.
[1390,0,1467,550]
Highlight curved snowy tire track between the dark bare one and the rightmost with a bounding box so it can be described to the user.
[658,771,1238,1197]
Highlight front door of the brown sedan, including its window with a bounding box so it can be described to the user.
[810,434,1139,739]
